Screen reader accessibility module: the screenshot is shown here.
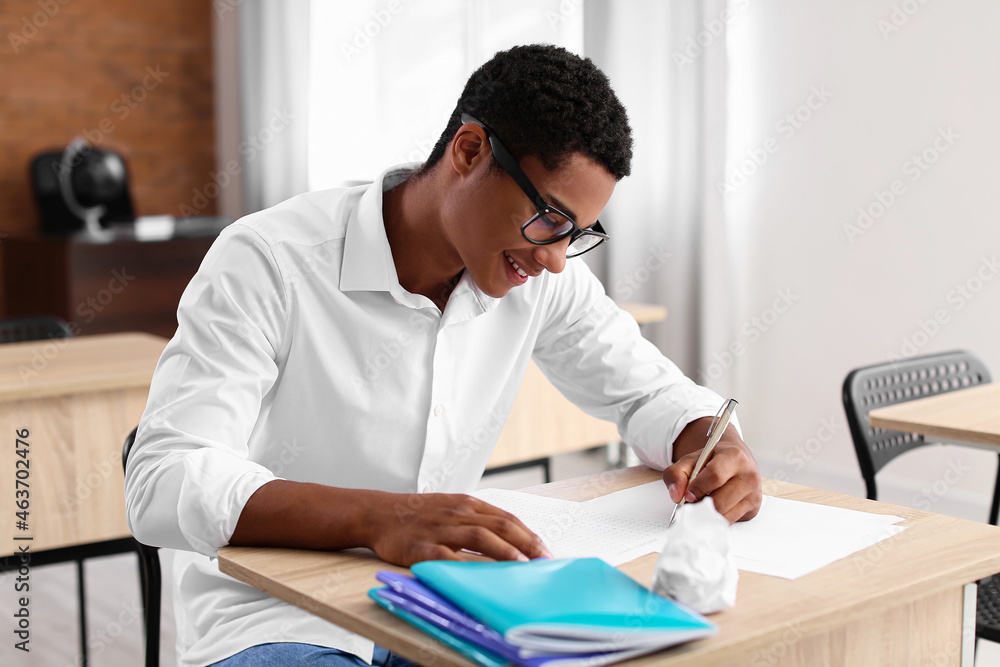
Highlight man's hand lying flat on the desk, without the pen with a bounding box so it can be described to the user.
[369,493,552,567]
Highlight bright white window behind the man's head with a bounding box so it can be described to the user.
[308,0,583,190]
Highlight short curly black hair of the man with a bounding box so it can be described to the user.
[421,44,632,181]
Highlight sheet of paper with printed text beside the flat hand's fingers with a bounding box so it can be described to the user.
[472,489,667,566]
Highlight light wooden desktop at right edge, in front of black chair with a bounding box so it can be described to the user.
[868,383,1000,452]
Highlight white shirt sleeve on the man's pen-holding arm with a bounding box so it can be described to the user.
[533,261,736,470]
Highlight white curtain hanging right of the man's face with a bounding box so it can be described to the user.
[584,0,736,394]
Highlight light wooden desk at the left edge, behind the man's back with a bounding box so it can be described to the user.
[0,333,167,557]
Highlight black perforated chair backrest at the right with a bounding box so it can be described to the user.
[843,350,990,500]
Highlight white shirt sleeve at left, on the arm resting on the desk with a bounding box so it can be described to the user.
[125,223,287,557]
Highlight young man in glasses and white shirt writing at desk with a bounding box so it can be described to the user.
[126,46,761,667]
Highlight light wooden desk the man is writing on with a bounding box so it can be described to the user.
[219,467,1000,667]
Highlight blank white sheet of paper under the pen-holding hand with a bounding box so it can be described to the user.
[580,481,905,579]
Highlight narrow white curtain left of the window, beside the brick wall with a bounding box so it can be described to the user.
[238,0,309,213]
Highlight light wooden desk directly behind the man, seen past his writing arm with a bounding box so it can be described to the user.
[487,303,667,468]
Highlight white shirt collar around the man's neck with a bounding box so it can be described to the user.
[340,162,500,323]
